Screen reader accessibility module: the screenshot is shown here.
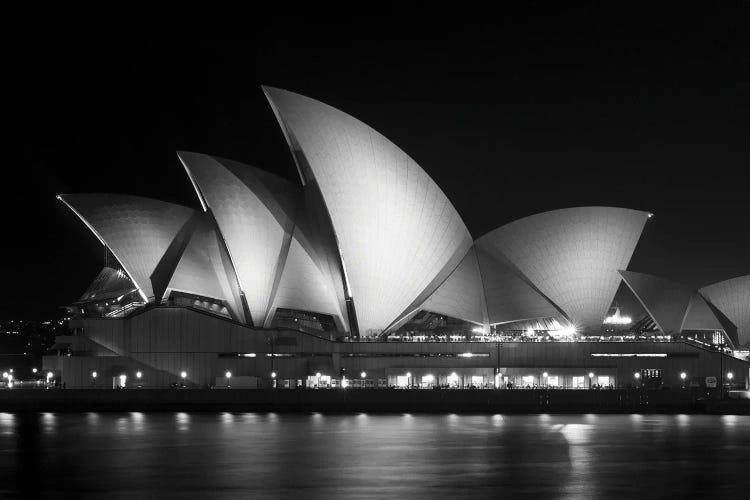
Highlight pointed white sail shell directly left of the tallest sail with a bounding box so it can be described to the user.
[178,151,300,326]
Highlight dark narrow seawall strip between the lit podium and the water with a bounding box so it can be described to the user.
[0,389,750,415]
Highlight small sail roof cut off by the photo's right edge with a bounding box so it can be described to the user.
[699,275,750,346]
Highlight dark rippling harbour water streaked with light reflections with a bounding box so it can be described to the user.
[0,412,750,499]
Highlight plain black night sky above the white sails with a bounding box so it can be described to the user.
[0,2,750,318]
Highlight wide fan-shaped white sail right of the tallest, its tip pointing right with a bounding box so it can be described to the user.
[477,207,649,331]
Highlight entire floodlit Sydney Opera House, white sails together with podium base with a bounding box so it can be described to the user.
[44,87,750,389]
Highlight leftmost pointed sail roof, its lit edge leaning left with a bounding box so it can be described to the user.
[58,194,196,301]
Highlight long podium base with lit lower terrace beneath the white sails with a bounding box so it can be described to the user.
[42,307,750,390]
